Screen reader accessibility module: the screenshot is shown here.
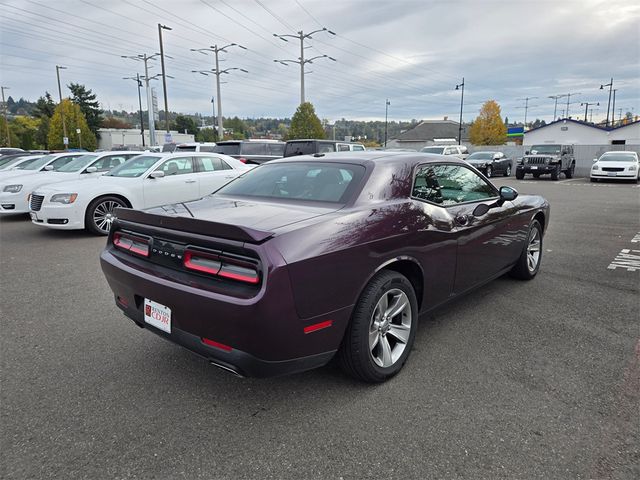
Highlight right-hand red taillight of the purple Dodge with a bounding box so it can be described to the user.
[183,249,260,285]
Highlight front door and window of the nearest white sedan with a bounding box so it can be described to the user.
[143,156,200,208]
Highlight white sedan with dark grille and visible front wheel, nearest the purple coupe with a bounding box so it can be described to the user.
[30,152,252,235]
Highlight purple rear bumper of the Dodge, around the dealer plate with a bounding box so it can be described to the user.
[100,249,351,377]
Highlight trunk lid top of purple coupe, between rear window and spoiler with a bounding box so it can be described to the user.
[145,196,342,232]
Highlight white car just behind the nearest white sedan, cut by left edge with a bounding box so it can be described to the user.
[0,152,143,215]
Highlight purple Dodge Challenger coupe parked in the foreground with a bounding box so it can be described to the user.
[101,152,549,382]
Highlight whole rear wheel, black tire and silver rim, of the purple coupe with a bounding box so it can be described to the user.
[337,270,418,383]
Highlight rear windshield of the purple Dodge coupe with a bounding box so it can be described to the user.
[216,162,365,203]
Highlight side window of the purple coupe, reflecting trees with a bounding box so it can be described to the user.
[412,165,498,206]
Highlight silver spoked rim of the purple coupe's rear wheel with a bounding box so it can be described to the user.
[369,288,411,368]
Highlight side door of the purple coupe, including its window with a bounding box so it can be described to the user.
[418,164,524,293]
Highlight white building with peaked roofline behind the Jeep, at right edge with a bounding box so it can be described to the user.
[523,118,640,145]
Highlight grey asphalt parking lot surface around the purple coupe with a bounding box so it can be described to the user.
[0,178,640,479]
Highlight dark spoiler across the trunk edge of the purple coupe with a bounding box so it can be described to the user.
[115,208,274,243]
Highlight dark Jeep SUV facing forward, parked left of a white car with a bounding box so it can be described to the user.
[516,144,576,180]
